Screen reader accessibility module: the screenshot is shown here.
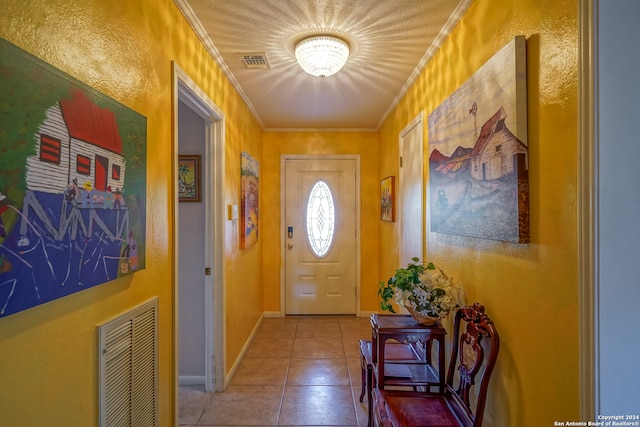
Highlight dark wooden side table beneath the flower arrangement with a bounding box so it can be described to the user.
[370,314,447,393]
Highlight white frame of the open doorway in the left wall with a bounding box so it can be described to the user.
[171,63,226,402]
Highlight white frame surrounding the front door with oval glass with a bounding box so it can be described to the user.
[280,154,362,317]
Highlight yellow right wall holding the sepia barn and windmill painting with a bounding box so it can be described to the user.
[378,0,579,427]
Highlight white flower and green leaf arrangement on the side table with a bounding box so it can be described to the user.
[378,258,460,318]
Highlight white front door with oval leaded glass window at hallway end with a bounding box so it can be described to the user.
[283,158,356,314]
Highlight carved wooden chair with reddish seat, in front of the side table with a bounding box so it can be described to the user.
[372,303,500,427]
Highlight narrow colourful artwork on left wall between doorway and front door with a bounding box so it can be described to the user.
[240,152,260,249]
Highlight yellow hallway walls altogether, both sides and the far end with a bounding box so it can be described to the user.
[0,0,579,427]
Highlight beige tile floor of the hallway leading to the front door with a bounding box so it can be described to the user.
[179,316,371,427]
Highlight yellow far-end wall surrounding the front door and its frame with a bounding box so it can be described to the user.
[260,132,380,312]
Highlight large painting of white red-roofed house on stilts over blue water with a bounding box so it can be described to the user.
[0,40,146,317]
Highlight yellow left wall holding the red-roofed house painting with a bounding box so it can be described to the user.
[0,0,263,427]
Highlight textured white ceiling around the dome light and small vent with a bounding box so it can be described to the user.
[175,0,472,130]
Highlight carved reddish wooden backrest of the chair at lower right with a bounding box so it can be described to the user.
[446,303,500,427]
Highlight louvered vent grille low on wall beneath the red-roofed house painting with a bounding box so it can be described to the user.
[98,298,158,427]
